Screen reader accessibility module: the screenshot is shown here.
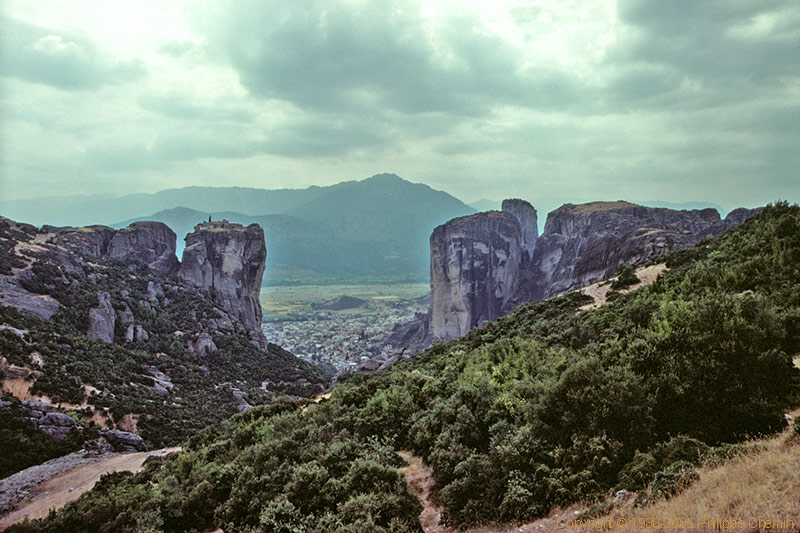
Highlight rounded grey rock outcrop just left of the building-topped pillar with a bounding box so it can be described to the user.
[108,222,181,276]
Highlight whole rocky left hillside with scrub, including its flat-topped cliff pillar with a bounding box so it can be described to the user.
[0,218,326,473]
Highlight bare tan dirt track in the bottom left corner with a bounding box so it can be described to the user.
[0,447,180,531]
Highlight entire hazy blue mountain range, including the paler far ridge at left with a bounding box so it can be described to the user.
[0,174,475,283]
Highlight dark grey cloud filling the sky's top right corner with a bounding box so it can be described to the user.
[607,0,800,105]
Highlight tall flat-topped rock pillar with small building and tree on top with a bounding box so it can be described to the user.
[180,221,267,337]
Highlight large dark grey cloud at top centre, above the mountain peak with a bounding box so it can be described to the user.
[206,1,574,116]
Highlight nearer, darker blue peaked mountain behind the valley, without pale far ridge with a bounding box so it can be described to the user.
[112,174,474,282]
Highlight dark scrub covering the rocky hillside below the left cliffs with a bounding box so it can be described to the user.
[0,239,328,471]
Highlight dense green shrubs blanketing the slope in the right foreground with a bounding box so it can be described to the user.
[7,204,800,532]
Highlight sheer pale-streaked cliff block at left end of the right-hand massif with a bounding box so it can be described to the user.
[429,211,522,340]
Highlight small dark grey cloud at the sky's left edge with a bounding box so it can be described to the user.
[0,15,144,90]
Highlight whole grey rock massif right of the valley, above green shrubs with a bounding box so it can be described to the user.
[428,200,755,342]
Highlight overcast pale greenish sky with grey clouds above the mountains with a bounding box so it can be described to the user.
[0,0,800,208]
